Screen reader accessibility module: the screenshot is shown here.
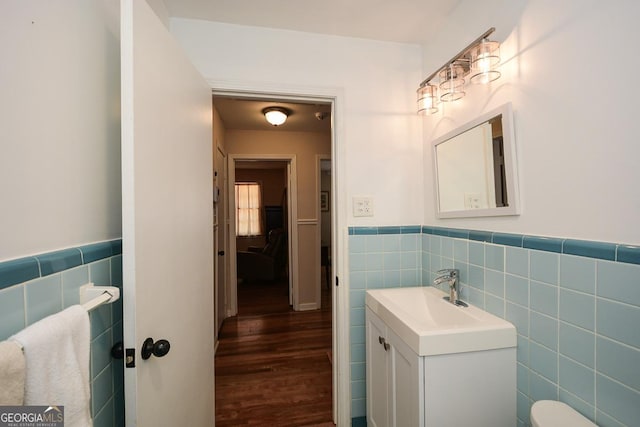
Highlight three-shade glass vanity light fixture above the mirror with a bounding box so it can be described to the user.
[417,27,500,114]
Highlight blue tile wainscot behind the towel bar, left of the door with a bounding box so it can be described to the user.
[0,240,124,427]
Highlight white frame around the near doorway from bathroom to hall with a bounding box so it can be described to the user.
[211,82,351,426]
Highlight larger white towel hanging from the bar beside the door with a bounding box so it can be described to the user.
[12,305,92,427]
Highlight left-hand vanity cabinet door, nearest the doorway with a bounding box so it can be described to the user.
[366,308,390,427]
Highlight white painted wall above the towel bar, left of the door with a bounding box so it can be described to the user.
[0,0,121,261]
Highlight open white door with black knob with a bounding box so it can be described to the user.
[117,0,215,427]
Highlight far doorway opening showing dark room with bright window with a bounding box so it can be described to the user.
[234,154,298,315]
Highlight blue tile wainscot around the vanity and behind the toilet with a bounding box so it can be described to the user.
[349,226,640,427]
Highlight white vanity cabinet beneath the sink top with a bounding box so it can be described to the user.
[366,303,516,427]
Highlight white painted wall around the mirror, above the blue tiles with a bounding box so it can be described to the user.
[423,0,640,244]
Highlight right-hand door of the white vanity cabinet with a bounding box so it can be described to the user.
[387,329,424,427]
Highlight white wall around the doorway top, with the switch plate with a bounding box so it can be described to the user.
[171,19,424,225]
